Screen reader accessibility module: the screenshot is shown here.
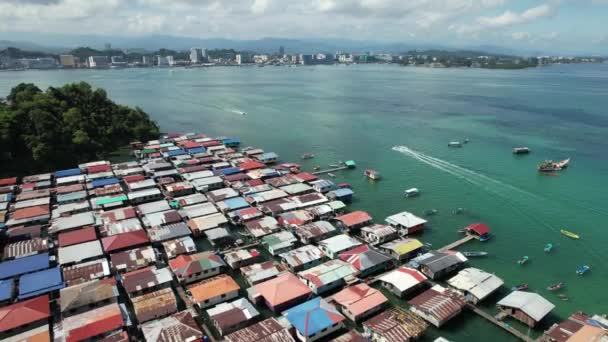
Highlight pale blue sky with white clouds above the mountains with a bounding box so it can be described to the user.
[0,0,608,53]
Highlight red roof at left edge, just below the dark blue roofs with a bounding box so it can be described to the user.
[0,295,51,332]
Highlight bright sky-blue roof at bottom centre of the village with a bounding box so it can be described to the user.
[283,297,344,336]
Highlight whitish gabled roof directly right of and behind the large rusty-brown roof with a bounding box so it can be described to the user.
[448,267,504,300]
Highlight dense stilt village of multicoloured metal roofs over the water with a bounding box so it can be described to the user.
[0,134,608,342]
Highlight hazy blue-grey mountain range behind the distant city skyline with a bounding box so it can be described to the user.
[0,32,600,56]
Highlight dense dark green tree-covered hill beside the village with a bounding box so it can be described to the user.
[0,82,159,175]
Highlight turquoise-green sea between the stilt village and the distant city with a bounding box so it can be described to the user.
[0,64,608,341]
